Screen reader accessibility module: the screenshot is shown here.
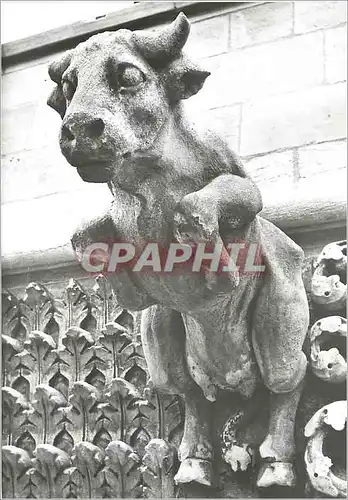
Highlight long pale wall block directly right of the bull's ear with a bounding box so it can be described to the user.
[194,33,324,109]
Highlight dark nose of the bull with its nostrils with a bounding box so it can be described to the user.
[61,113,105,142]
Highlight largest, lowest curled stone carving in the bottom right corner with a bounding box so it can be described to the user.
[304,401,347,498]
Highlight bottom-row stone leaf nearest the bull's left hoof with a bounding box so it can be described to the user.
[141,439,178,498]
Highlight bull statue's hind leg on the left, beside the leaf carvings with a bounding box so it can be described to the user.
[141,305,213,486]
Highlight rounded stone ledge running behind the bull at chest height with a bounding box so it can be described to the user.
[2,190,347,279]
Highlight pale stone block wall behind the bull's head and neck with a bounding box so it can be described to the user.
[1,0,346,262]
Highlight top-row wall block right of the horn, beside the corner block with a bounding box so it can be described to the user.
[230,2,293,49]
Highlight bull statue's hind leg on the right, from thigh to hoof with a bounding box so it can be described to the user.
[253,262,308,487]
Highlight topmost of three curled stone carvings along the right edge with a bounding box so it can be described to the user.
[311,241,347,311]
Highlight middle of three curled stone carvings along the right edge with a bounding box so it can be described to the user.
[309,316,347,383]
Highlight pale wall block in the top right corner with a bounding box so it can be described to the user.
[294,0,347,33]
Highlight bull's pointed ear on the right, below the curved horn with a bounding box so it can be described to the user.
[166,56,210,101]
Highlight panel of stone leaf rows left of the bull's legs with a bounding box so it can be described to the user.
[2,276,184,498]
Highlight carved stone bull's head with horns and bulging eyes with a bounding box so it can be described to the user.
[48,13,209,182]
